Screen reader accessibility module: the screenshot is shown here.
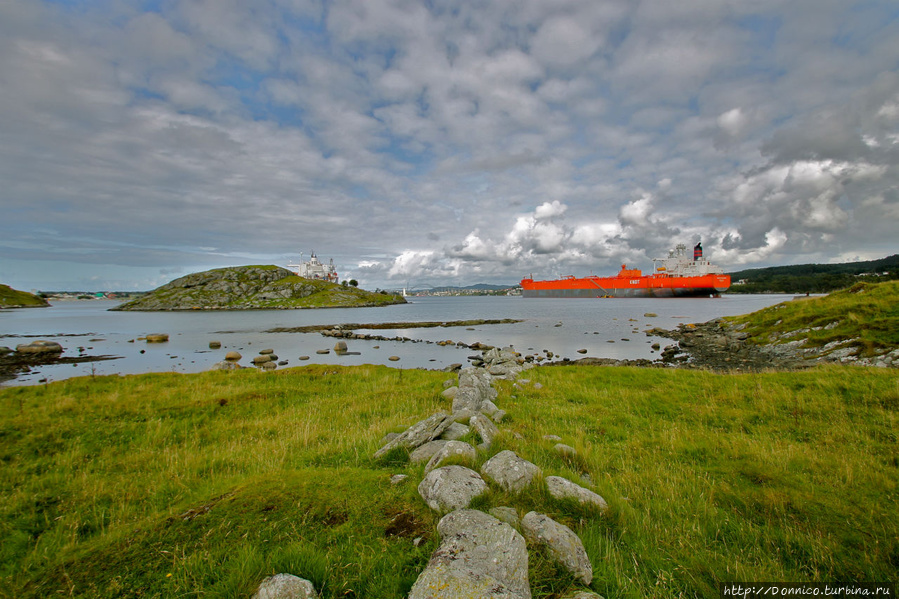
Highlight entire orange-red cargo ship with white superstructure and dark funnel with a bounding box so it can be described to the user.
[521,243,730,297]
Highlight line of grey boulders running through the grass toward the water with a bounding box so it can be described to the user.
[254,348,608,599]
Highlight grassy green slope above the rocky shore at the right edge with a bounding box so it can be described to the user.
[728,281,899,356]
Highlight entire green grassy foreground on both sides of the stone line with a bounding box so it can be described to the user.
[0,366,899,598]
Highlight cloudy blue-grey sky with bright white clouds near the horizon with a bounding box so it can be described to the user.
[0,0,899,290]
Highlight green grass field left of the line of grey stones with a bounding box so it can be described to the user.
[0,367,442,597]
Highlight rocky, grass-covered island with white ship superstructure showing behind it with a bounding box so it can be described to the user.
[111,266,406,311]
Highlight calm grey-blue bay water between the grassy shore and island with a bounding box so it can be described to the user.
[0,295,792,385]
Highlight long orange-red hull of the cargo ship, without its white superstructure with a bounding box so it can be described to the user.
[521,270,730,298]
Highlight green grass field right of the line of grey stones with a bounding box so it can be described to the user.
[503,367,899,597]
